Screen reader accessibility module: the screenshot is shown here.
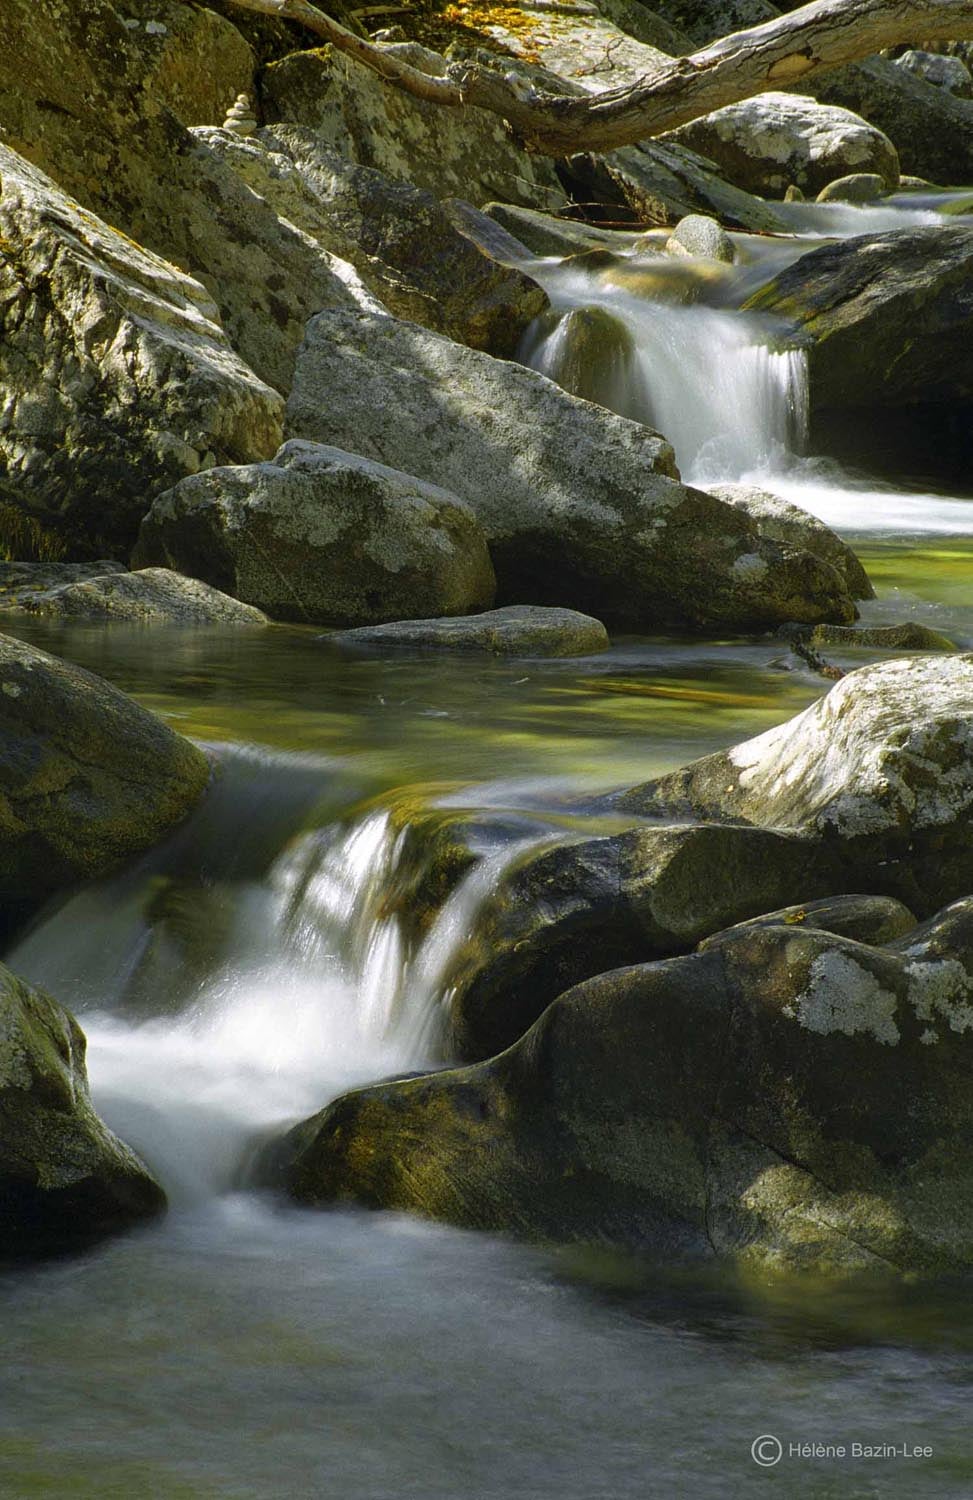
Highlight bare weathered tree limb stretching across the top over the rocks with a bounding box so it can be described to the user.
[221,0,973,156]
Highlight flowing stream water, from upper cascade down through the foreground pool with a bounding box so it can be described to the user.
[0,200,973,1500]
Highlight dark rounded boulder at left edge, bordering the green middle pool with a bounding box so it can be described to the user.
[0,636,210,909]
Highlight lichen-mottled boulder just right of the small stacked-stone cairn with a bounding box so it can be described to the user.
[261,47,564,213]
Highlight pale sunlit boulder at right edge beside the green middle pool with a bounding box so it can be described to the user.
[618,656,973,917]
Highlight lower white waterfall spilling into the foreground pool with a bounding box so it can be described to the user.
[6,755,534,1205]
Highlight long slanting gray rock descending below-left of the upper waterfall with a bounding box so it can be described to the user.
[284,314,853,629]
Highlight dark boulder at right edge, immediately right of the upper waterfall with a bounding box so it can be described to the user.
[747,228,973,420]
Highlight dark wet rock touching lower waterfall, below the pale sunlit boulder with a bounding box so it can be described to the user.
[444,824,837,1061]
